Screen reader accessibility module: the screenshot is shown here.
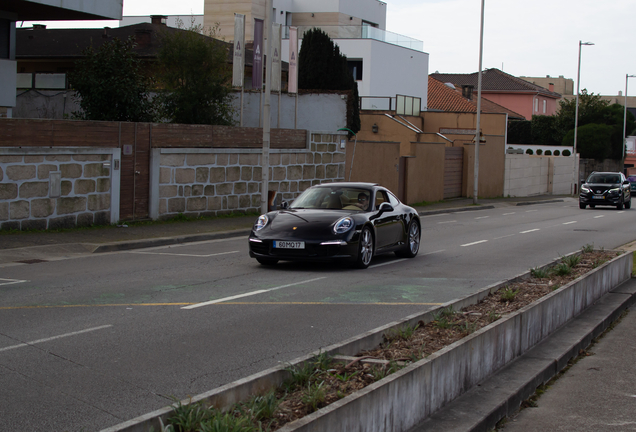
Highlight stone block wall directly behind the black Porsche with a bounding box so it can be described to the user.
[155,132,346,219]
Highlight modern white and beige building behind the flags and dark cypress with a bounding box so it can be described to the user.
[204,0,428,107]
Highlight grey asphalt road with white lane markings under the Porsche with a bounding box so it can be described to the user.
[0,199,636,431]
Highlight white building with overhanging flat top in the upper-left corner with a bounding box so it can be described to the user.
[0,0,123,117]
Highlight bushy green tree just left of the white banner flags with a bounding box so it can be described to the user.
[158,24,233,125]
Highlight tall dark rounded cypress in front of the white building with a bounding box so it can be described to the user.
[298,28,360,132]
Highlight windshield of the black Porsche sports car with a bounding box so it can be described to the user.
[289,186,371,211]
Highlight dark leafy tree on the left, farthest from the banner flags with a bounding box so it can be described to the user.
[69,38,155,122]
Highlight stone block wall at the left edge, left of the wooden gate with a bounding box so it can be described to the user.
[0,148,120,230]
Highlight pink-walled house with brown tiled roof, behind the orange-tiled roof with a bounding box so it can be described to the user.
[429,69,561,120]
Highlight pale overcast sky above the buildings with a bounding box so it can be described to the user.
[27,0,636,96]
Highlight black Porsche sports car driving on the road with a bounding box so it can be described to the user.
[249,182,421,268]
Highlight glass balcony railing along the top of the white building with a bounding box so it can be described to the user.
[283,25,424,51]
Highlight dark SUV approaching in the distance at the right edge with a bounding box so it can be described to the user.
[579,172,632,210]
